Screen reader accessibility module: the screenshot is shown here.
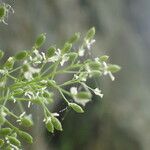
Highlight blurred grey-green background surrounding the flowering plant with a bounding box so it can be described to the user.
[0,0,150,150]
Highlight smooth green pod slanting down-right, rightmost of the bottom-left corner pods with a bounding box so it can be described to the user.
[18,131,33,144]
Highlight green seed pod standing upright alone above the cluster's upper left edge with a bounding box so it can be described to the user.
[35,33,46,48]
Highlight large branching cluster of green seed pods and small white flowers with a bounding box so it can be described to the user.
[0,28,120,150]
